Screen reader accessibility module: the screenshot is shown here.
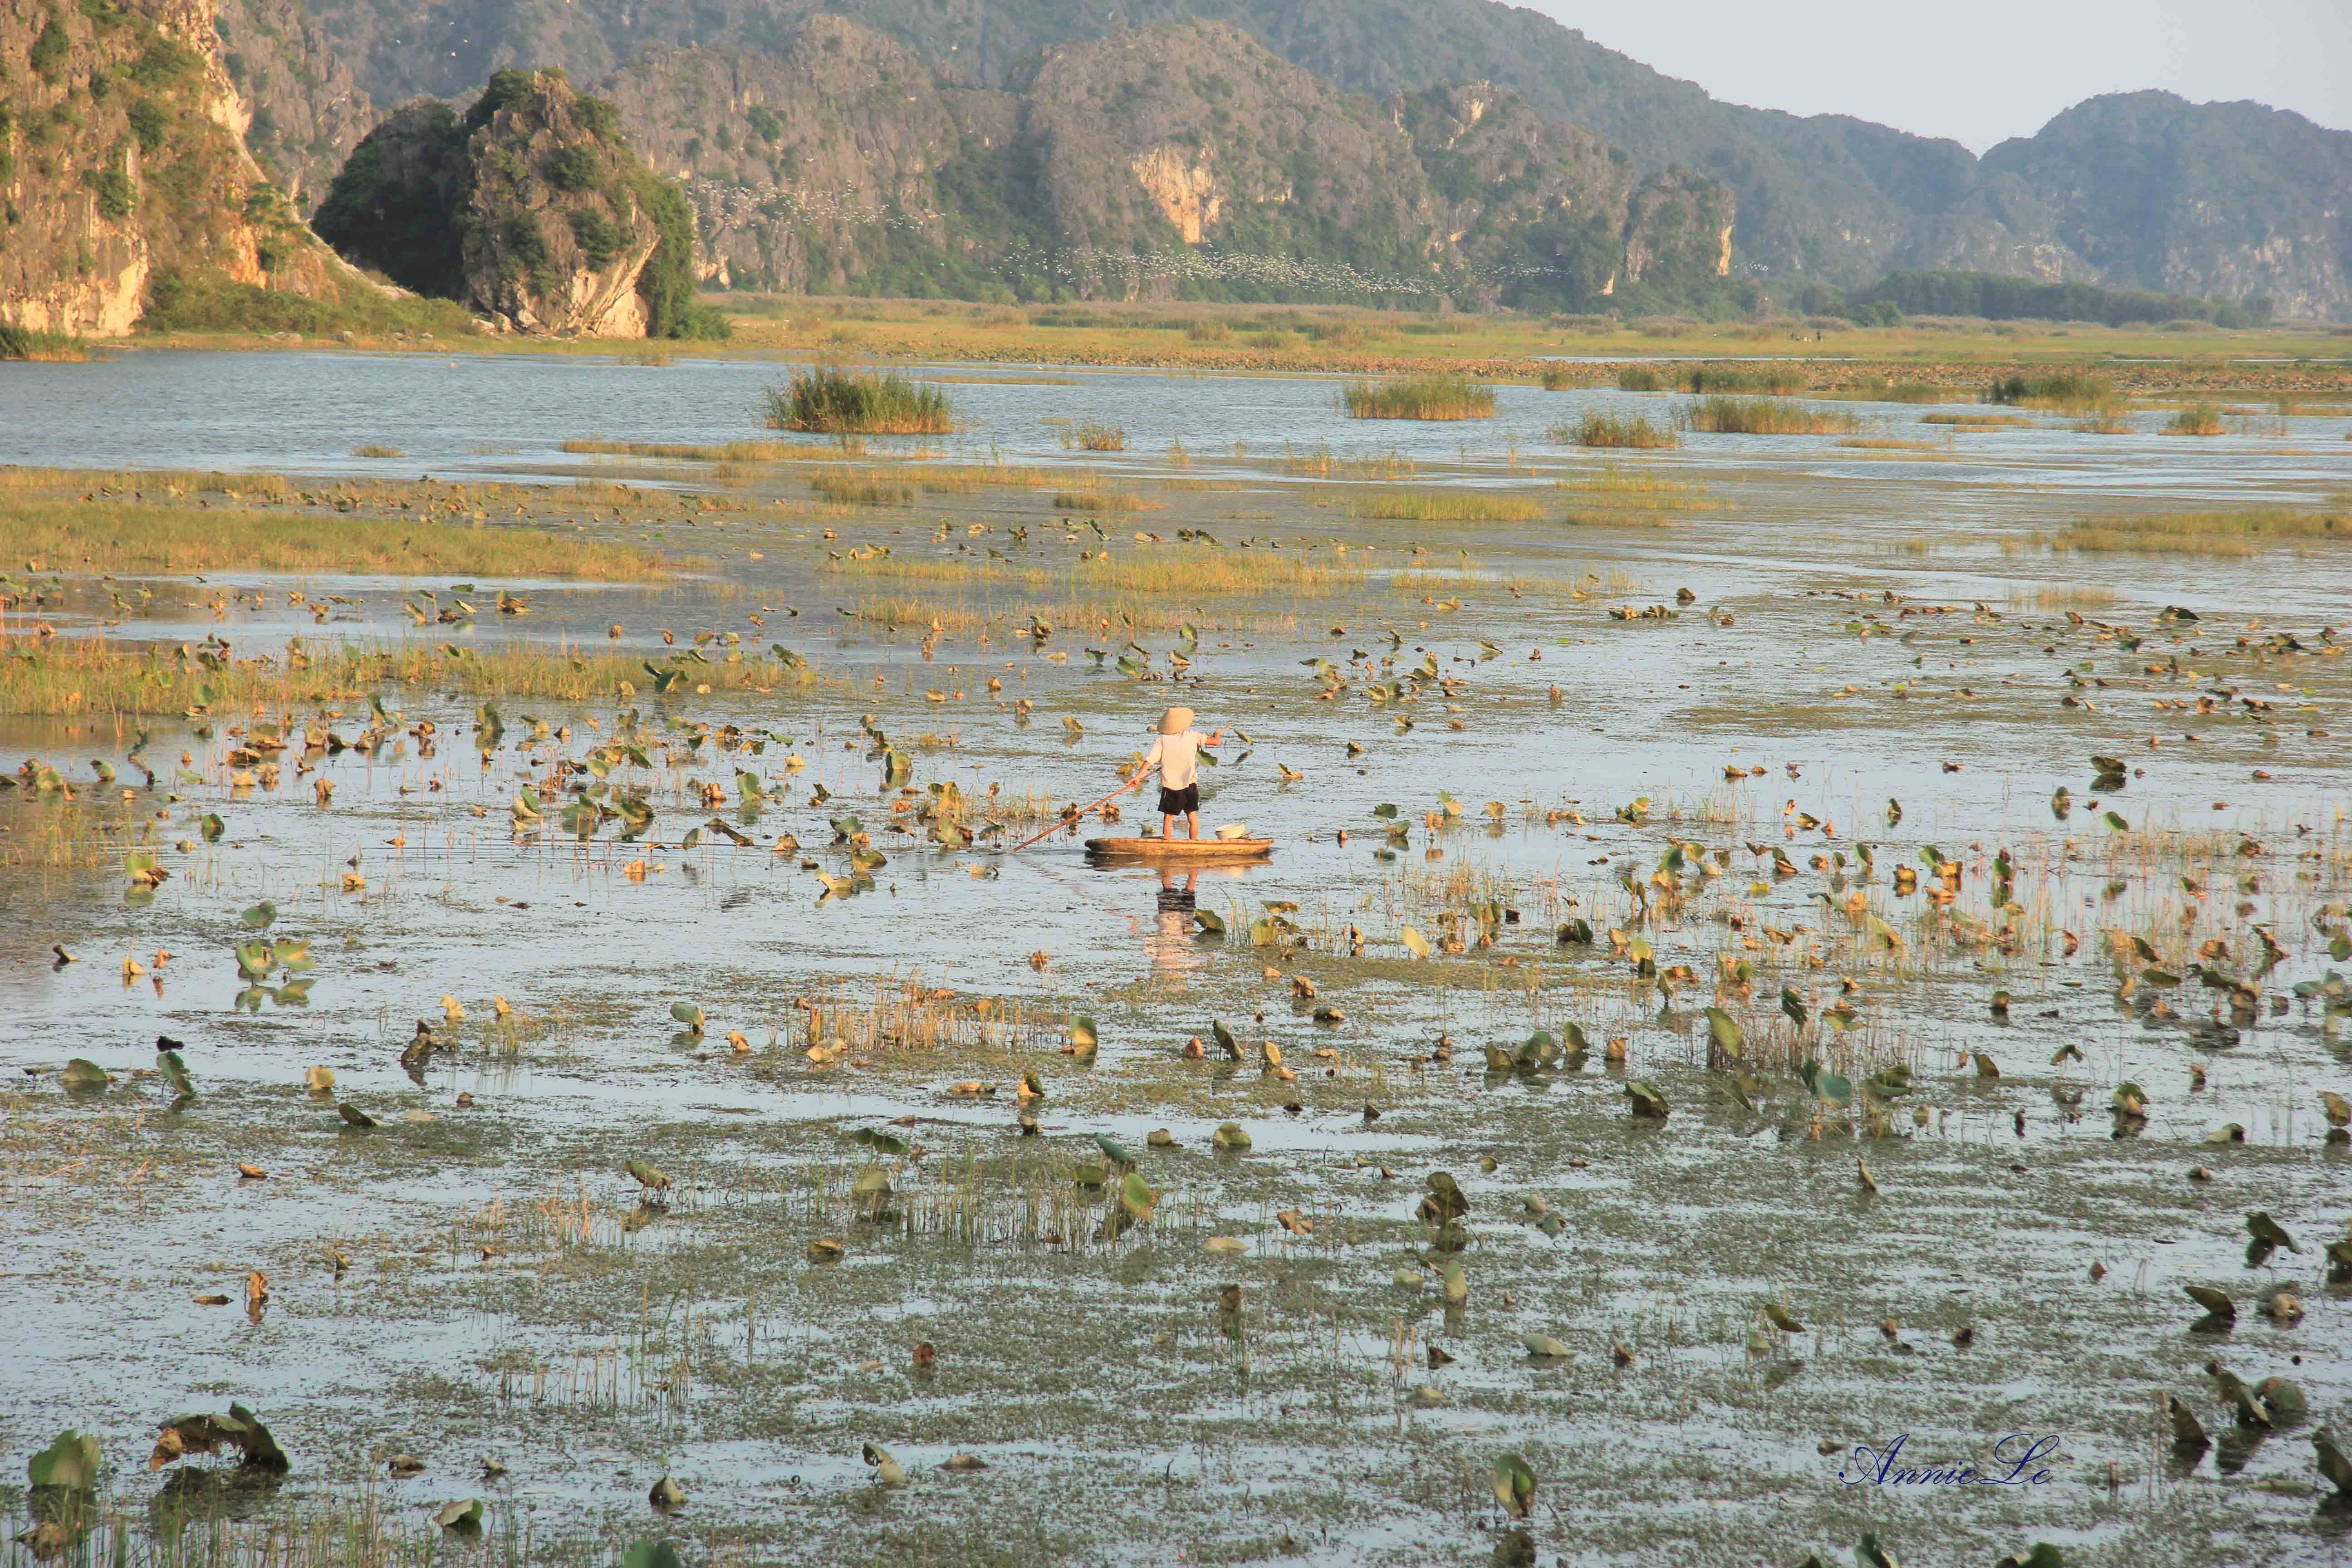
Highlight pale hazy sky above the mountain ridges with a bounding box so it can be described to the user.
[1519,0,2352,153]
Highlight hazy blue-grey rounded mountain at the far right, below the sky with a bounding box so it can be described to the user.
[1985,92,2352,320]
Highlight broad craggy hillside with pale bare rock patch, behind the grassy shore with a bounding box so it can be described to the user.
[604,19,1731,303]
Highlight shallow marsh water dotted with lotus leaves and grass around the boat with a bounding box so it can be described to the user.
[0,353,2352,1566]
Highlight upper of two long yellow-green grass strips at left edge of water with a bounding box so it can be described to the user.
[0,501,670,583]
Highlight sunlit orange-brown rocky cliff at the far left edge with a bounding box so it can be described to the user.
[0,0,334,336]
